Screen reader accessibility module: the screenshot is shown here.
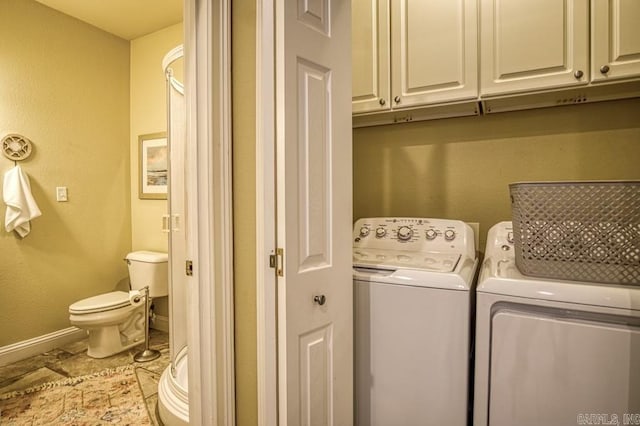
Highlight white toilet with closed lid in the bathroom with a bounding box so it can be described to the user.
[69,251,169,358]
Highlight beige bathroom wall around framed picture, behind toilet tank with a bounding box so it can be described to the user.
[130,24,183,317]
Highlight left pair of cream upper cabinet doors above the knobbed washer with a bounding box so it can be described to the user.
[352,0,478,113]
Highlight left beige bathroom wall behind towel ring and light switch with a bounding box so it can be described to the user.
[0,0,131,346]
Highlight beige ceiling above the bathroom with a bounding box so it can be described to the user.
[36,0,183,40]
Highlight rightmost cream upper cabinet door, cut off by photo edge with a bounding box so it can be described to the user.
[591,0,640,82]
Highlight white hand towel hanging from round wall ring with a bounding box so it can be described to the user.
[2,166,42,238]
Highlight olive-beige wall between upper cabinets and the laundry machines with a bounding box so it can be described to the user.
[353,99,640,251]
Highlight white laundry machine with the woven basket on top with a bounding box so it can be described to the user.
[474,222,640,426]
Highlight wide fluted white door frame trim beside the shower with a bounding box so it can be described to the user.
[184,0,235,426]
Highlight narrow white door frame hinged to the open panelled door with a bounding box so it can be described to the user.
[256,0,278,426]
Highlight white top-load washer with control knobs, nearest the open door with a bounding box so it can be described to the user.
[353,218,477,426]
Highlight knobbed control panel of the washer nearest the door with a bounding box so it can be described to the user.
[353,217,475,258]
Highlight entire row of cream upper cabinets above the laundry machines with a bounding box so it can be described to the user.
[352,0,640,123]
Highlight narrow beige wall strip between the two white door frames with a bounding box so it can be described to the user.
[231,1,258,426]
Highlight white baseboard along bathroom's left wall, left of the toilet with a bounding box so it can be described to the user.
[0,327,87,366]
